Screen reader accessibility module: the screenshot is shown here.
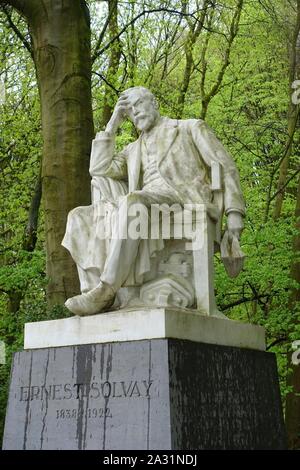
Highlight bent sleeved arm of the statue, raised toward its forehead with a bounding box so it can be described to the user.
[90,131,127,180]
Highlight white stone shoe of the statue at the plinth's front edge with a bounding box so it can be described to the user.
[65,281,116,316]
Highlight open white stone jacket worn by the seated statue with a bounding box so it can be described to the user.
[90,118,245,220]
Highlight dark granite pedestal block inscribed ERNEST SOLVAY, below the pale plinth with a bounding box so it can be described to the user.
[4,339,286,450]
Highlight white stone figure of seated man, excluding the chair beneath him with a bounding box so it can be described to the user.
[62,87,245,315]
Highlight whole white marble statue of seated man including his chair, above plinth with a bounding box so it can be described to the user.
[62,87,245,315]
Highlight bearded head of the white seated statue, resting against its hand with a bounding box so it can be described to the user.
[121,86,159,131]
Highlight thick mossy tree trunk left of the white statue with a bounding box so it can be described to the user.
[7,0,94,306]
